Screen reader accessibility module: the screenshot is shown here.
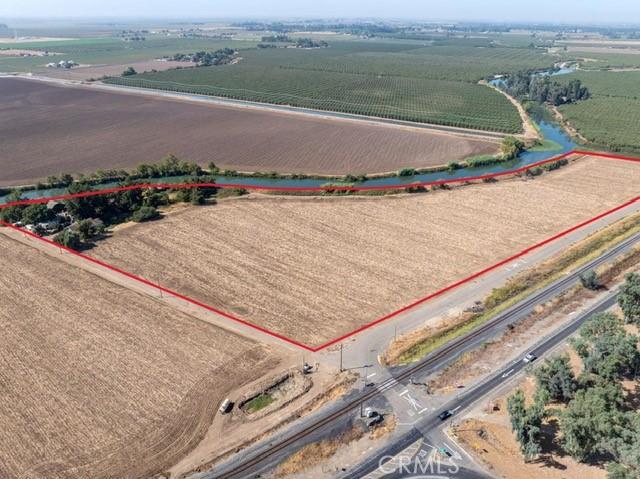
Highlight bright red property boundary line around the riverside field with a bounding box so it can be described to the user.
[0,150,640,352]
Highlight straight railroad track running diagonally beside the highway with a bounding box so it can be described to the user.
[214,233,640,479]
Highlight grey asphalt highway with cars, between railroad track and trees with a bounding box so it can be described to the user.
[343,289,618,479]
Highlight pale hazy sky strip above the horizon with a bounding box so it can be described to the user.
[0,0,640,24]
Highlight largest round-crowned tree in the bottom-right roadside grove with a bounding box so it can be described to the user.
[560,383,625,462]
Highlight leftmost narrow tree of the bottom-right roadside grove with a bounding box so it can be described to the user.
[507,390,546,462]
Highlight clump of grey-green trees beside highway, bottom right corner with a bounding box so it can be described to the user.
[507,273,640,479]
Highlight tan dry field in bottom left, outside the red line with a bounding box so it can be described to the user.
[0,235,274,479]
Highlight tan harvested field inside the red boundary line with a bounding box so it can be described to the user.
[89,158,640,345]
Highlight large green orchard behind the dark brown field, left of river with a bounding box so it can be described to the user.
[102,39,554,133]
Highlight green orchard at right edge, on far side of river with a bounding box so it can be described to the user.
[557,72,640,152]
